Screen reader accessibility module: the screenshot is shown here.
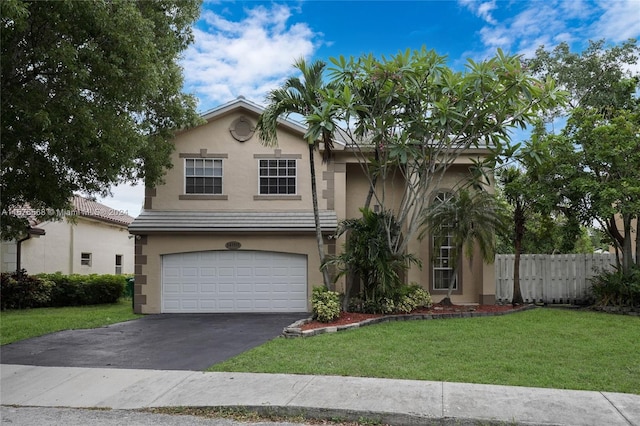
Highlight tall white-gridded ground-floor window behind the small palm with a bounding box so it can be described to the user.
[431,192,459,290]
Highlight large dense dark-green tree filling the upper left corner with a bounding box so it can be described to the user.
[0,0,200,239]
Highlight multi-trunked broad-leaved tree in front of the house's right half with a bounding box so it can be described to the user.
[331,48,562,260]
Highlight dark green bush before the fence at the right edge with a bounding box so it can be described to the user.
[591,266,640,308]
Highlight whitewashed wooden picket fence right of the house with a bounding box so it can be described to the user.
[495,253,616,303]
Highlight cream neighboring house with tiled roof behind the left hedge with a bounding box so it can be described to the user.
[0,196,134,274]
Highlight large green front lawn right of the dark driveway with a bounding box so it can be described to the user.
[208,309,640,394]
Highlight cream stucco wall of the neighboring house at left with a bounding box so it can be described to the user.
[14,218,134,274]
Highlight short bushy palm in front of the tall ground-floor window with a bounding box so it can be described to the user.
[420,189,508,305]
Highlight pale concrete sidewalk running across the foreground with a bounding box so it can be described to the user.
[0,364,640,426]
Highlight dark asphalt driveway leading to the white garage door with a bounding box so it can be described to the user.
[0,313,309,371]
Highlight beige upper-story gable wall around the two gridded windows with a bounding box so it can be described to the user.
[147,111,327,211]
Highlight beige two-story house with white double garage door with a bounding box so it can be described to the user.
[129,97,495,314]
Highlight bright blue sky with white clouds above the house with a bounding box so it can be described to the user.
[101,0,640,216]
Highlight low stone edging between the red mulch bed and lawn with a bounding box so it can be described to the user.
[282,305,537,338]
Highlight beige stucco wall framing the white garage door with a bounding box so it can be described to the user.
[134,233,322,314]
